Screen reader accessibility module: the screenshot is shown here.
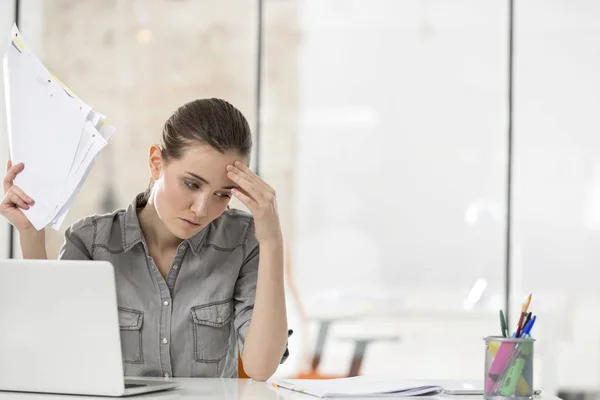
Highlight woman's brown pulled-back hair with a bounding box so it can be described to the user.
[144,98,252,200]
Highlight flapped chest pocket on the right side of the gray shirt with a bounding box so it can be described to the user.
[191,299,233,363]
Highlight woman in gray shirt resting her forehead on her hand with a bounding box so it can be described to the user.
[0,99,288,380]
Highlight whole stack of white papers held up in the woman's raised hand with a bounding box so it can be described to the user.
[3,25,115,230]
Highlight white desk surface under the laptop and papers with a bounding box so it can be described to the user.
[0,378,559,400]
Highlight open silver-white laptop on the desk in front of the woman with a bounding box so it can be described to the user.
[0,260,177,397]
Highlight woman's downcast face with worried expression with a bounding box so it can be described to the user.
[150,144,246,239]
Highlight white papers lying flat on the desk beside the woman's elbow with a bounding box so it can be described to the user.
[269,376,443,397]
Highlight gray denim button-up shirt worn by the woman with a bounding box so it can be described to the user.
[59,195,288,378]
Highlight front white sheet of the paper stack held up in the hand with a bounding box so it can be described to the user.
[5,40,86,228]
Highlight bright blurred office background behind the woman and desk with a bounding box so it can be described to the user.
[0,0,600,396]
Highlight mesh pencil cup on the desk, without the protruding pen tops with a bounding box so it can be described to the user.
[483,336,535,400]
